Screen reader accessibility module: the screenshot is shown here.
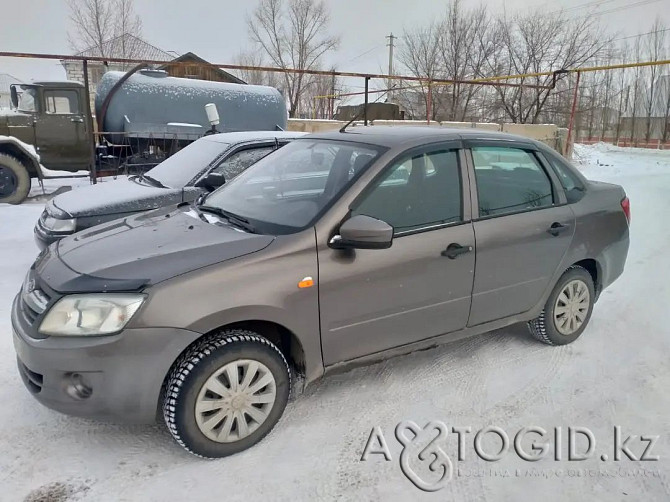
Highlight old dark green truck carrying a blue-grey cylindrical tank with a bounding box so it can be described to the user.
[0,69,287,204]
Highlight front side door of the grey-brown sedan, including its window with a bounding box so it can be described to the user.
[318,143,475,365]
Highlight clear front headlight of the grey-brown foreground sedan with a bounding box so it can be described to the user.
[39,293,146,336]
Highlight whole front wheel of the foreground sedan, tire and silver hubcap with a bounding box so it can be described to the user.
[163,329,291,458]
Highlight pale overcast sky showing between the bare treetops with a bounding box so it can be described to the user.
[0,0,670,86]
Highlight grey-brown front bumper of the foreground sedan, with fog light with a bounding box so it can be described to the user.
[12,296,201,423]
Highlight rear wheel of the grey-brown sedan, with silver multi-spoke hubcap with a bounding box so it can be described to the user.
[528,266,595,345]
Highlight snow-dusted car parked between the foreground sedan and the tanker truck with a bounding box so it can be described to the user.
[34,131,305,249]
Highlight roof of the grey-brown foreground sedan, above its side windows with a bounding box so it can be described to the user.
[308,126,537,148]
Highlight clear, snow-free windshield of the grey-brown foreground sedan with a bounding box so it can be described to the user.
[204,139,382,235]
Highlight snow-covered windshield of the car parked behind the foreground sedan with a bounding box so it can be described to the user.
[147,138,230,188]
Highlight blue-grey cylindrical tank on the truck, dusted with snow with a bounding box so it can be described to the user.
[95,70,288,143]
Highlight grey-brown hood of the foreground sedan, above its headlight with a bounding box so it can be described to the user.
[40,206,274,293]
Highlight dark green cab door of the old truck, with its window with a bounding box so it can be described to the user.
[35,89,91,171]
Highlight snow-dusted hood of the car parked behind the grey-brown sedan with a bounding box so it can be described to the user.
[50,178,182,218]
